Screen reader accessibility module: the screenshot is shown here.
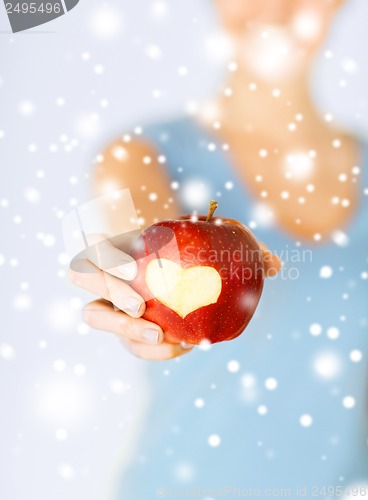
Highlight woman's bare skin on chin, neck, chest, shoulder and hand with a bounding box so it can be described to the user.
[71,0,360,360]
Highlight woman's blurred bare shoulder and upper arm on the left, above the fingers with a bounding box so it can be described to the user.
[91,118,193,222]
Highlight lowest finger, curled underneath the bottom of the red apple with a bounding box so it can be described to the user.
[121,339,194,361]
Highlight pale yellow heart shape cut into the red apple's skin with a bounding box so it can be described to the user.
[145,259,222,319]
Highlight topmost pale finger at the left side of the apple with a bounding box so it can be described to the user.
[83,235,137,281]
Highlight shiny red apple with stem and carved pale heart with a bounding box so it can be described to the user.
[132,201,264,344]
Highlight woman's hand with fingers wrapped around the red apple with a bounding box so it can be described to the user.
[69,240,281,360]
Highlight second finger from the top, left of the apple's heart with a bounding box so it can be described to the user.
[69,264,146,318]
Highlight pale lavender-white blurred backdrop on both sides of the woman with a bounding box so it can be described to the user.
[0,0,368,500]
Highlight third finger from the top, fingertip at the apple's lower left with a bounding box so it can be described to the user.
[83,300,164,345]
